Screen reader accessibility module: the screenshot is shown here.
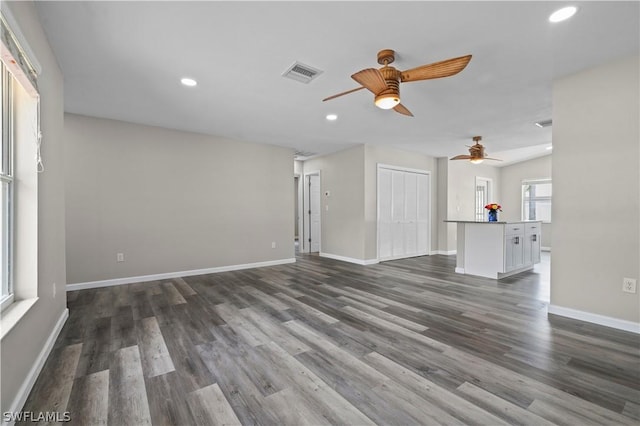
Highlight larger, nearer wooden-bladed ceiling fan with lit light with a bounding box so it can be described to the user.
[322,49,471,117]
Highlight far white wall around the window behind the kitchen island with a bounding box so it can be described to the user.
[499,155,553,248]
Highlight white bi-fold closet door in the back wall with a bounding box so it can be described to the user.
[378,166,430,261]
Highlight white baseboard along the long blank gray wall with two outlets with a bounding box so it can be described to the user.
[67,258,296,291]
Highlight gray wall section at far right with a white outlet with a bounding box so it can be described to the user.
[551,56,640,323]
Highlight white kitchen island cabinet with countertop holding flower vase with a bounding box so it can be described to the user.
[446,220,542,279]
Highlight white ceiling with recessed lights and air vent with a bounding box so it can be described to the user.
[37,1,640,164]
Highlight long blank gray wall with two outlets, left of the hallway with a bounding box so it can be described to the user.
[65,114,294,284]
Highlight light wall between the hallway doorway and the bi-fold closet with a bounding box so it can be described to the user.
[304,145,364,260]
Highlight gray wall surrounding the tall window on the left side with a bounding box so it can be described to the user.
[0,1,66,412]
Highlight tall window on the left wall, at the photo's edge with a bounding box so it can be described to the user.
[0,62,14,308]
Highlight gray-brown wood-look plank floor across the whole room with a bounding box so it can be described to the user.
[24,255,640,426]
